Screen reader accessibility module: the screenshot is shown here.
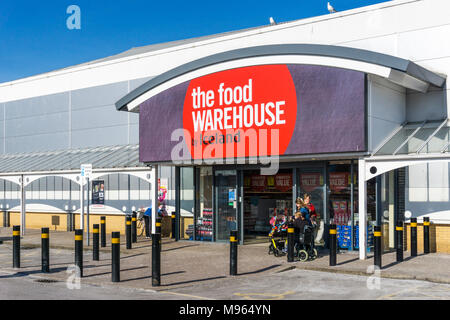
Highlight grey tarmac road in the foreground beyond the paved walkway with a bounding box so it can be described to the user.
[0,269,450,300]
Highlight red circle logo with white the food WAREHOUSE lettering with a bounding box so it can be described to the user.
[183,65,297,159]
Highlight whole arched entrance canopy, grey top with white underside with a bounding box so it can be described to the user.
[116,44,446,112]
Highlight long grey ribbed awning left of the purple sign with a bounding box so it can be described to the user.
[0,145,144,175]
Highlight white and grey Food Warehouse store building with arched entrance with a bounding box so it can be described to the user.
[0,0,450,259]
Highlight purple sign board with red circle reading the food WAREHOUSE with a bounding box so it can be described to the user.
[139,64,366,162]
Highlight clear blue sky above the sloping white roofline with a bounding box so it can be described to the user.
[0,0,387,83]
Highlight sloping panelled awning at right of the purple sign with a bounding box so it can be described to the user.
[372,119,450,156]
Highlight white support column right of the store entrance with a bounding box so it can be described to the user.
[358,159,367,260]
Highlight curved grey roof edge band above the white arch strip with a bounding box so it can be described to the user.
[116,44,446,111]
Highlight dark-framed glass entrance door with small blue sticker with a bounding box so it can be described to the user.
[215,170,239,241]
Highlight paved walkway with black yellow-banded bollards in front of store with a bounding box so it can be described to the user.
[0,228,450,290]
